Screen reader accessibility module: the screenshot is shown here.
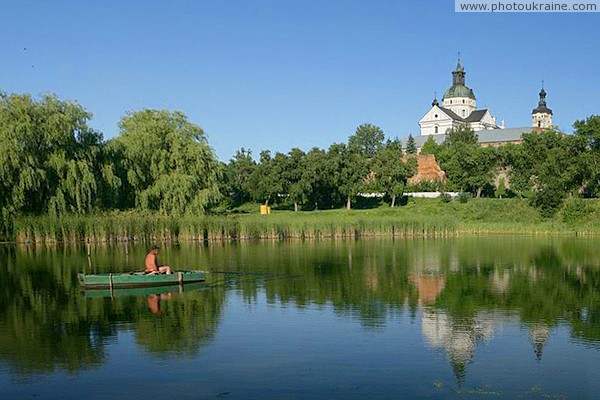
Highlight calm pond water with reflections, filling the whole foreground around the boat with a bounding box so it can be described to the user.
[0,237,600,400]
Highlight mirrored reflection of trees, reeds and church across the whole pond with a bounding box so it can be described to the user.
[0,237,600,383]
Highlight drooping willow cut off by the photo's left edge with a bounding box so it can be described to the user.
[0,93,111,228]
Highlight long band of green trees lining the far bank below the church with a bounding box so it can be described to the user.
[0,92,600,233]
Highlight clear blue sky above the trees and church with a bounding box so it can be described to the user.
[0,0,600,161]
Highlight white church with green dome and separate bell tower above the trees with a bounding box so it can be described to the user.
[414,59,553,150]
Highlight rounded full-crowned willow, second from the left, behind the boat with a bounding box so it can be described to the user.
[110,110,221,214]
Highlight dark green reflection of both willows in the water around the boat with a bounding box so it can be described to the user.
[0,247,224,377]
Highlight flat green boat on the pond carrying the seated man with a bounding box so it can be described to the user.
[77,271,206,290]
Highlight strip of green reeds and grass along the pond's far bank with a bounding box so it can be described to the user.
[7,199,600,243]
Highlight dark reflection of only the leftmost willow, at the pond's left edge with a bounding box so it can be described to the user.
[0,248,112,376]
